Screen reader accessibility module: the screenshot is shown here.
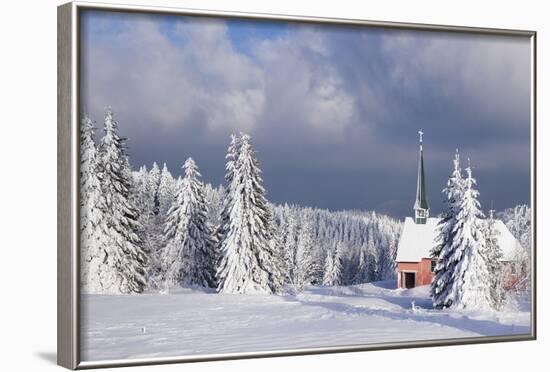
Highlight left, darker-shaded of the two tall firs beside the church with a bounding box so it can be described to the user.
[430,149,465,308]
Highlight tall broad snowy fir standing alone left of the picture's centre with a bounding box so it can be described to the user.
[218,134,281,293]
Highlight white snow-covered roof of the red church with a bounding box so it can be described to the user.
[396,217,521,262]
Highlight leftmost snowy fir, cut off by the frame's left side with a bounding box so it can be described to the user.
[80,116,112,293]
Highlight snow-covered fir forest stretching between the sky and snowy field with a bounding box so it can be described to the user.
[80,109,531,307]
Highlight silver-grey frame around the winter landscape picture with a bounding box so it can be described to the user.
[57,1,537,369]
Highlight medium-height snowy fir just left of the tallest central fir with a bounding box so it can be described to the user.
[163,158,216,287]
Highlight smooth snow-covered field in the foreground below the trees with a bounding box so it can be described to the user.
[81,281,530,361]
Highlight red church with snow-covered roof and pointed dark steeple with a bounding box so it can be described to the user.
[396,131,521,288]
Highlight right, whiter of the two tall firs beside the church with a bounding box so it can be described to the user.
[442,161,492,309]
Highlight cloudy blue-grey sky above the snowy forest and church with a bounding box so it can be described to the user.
[81,11,530,218]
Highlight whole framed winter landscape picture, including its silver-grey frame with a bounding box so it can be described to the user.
[57,2,536,369]
